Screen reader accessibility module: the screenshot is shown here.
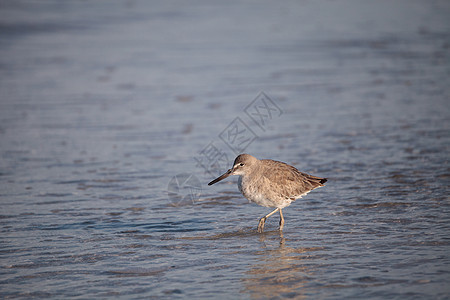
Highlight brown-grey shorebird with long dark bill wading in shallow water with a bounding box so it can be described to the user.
[208,154,327,233]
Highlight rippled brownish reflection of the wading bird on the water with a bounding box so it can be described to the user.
[244,232,323,299]
